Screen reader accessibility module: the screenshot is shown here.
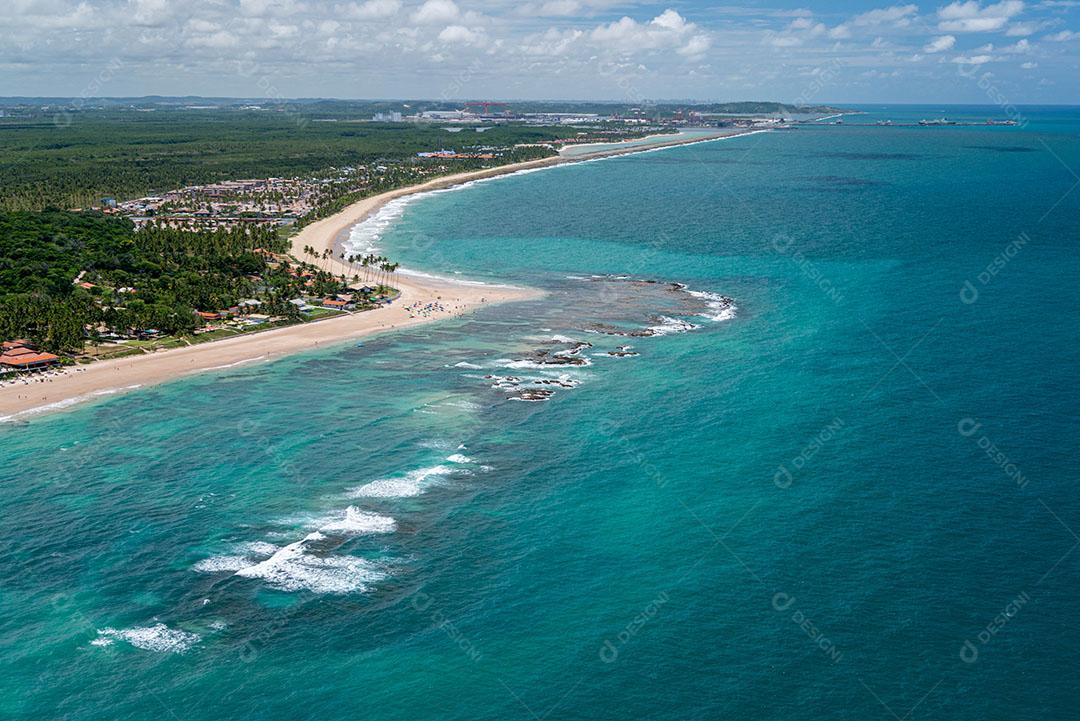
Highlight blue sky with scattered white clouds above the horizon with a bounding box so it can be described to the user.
[0,0,1080,105]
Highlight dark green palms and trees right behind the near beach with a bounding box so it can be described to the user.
[0,210,301,351]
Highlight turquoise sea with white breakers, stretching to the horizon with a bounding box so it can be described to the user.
[0,108,1080,721]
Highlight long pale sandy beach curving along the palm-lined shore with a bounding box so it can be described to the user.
[0,130,747,421]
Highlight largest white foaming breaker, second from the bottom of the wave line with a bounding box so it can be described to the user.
[237,531,387,594]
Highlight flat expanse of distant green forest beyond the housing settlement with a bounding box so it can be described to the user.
[0,110,575,210]
